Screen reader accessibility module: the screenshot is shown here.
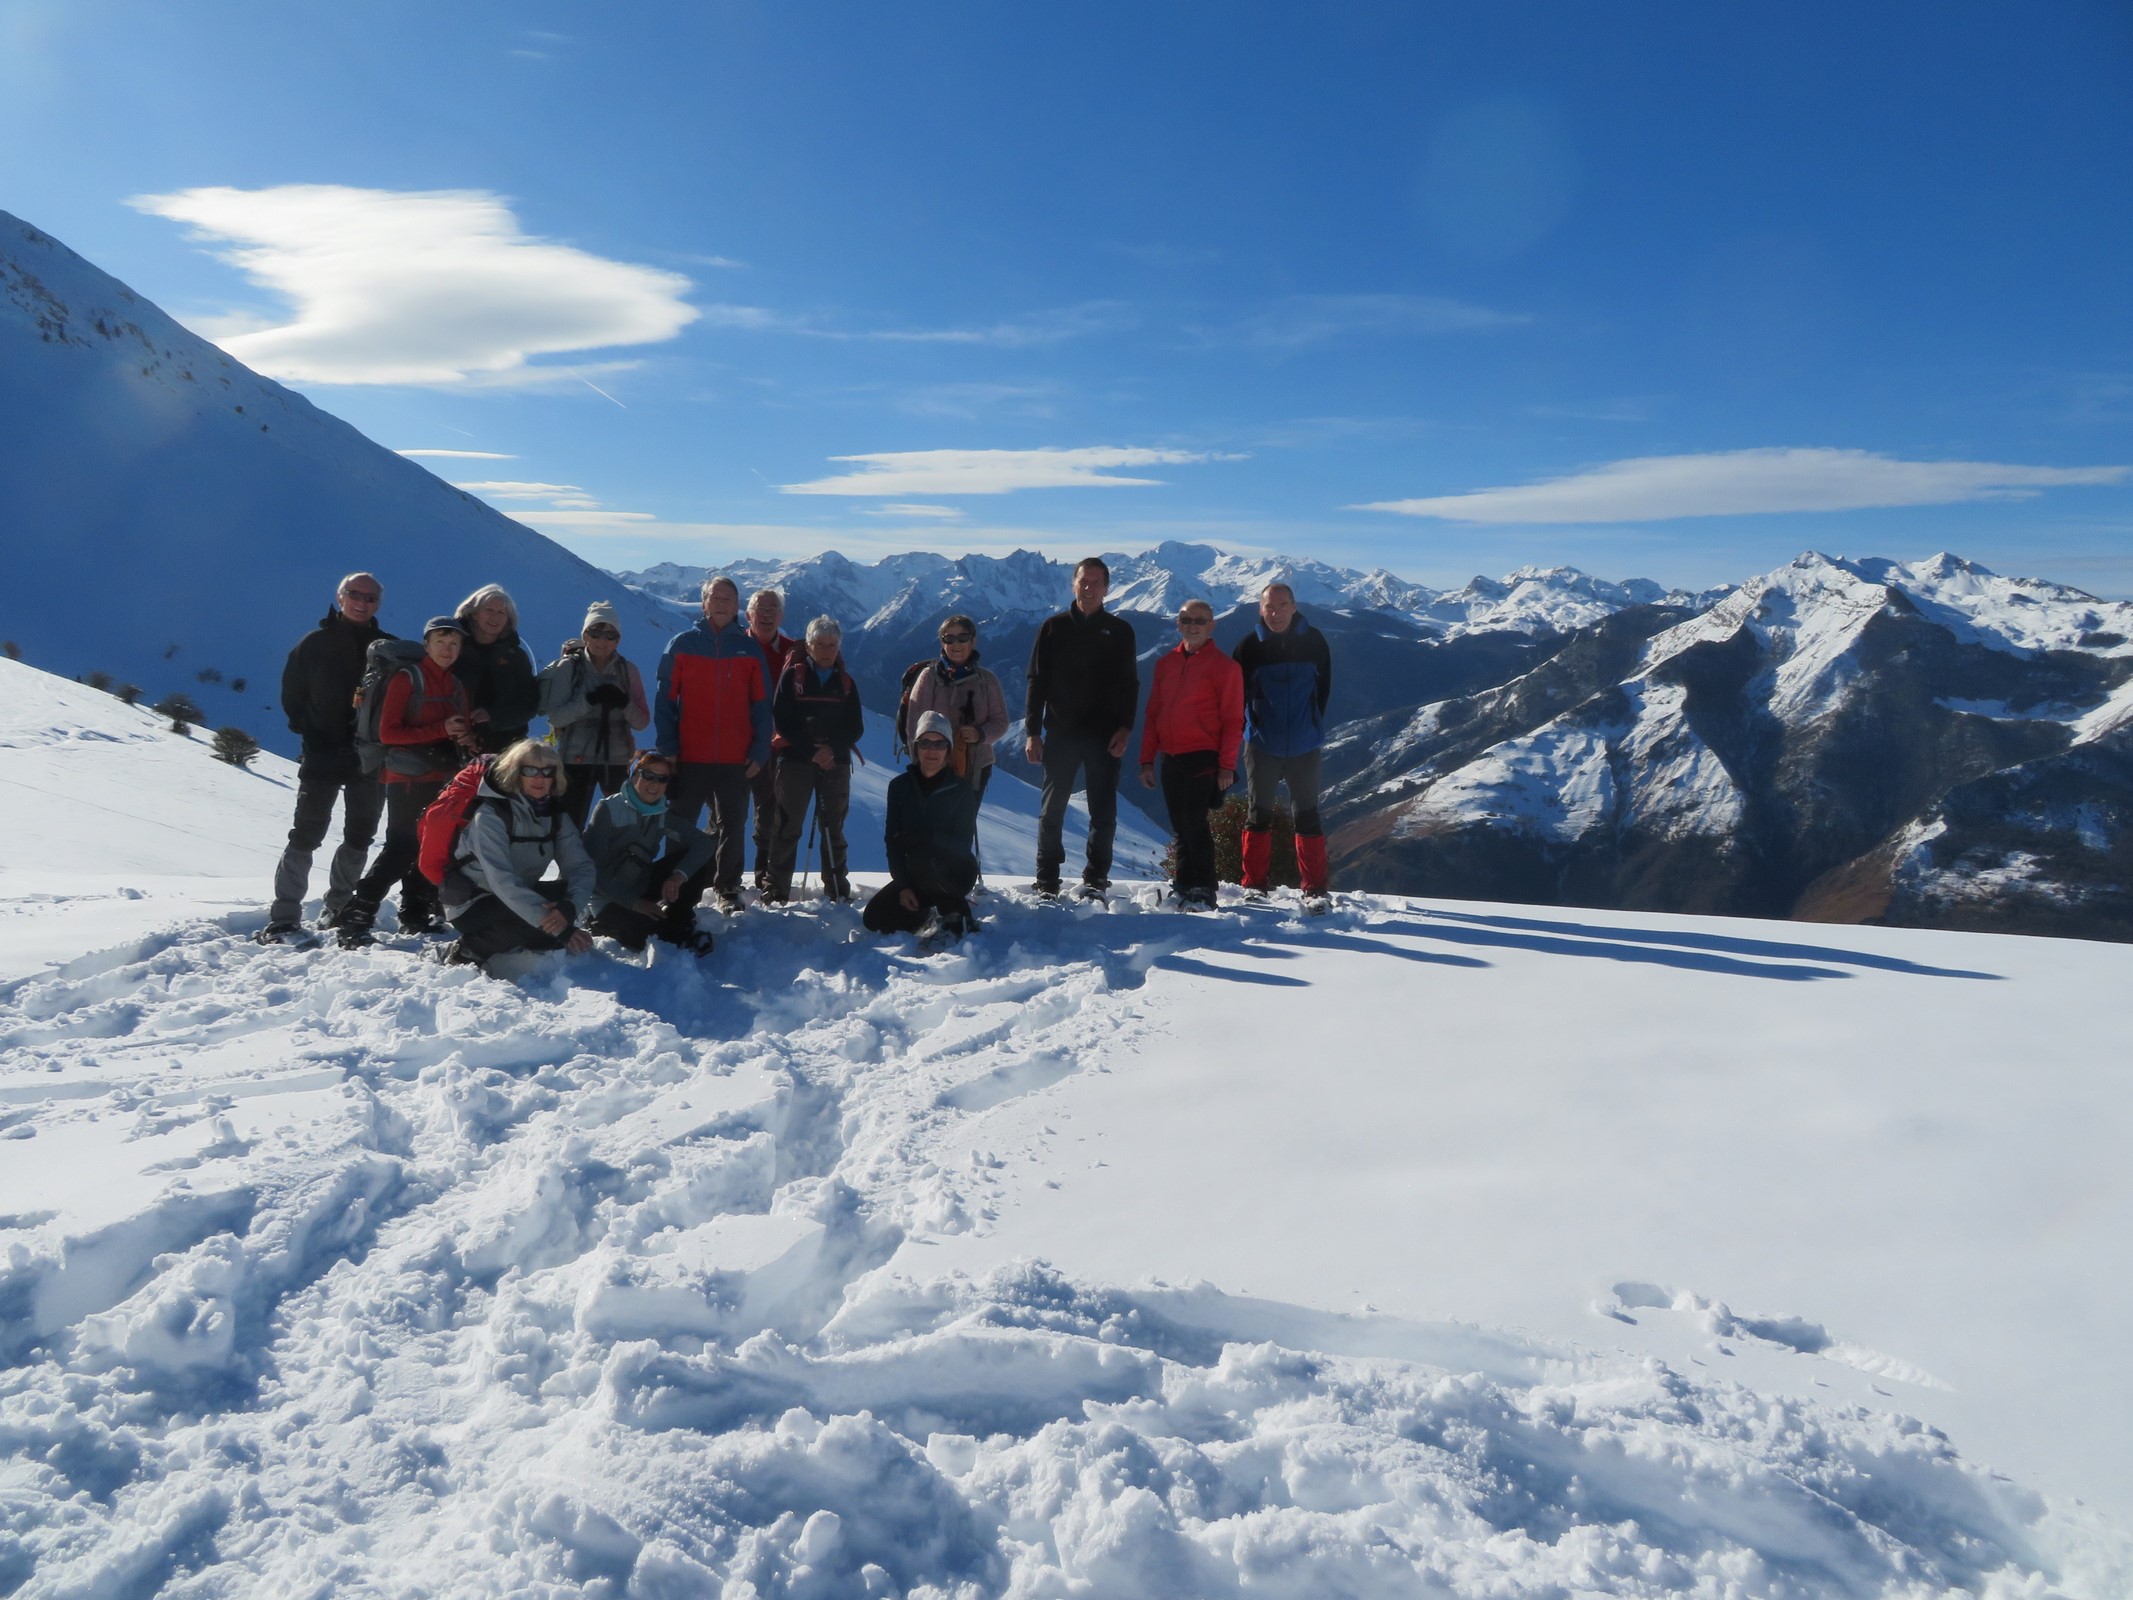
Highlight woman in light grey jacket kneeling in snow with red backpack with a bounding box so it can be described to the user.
[444,738,593,964]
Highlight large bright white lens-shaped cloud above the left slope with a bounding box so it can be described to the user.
[130,183,697,386]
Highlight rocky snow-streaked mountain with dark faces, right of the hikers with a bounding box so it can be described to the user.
[1333,555,2133,937]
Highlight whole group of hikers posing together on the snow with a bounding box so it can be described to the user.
[258,557,1333,964]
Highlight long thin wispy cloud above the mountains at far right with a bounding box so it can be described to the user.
[1350,448,2133,523]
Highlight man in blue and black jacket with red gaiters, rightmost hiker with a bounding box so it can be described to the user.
[1233,582,1333,898]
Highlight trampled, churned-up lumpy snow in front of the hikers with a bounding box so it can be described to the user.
[0,900,2133,1598]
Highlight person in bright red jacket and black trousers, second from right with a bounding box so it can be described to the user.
[1141,599,1244,911]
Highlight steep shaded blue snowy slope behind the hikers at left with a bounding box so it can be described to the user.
[0,213,672,753]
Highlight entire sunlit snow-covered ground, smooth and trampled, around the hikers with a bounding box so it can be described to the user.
[0,663,2133,1600]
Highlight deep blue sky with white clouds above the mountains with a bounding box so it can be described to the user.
[0,0,2133,595]
